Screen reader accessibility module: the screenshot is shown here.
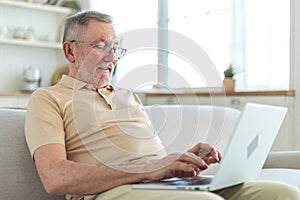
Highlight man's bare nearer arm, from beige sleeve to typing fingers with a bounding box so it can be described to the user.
[34,144,207,194]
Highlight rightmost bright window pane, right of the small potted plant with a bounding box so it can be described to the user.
[230,0,290,90]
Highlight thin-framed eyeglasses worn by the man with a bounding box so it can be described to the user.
[70,40,127,60]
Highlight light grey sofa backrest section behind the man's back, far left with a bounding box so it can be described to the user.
[0,109,65,200]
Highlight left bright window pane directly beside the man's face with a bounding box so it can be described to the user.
[90,0,158,89]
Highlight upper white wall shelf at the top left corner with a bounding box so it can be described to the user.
[0,0,72,15]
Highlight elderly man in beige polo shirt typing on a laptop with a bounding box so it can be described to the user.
[25,11,300,200]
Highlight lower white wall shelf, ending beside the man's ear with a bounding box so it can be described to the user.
[0,38,62,49]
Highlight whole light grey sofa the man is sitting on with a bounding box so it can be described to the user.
[0,105,300,200]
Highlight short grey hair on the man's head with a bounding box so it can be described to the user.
[63,10,113,42]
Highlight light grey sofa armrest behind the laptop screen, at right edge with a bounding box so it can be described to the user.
[263,151,300,169]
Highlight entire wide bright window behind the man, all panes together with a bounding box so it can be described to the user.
[91,0,290,90]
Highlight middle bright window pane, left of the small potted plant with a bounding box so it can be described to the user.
[169,0,231,88]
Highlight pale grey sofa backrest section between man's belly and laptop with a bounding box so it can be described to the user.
[145,105,241,153]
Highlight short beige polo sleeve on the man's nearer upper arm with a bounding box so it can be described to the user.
[25,88,65,157]
